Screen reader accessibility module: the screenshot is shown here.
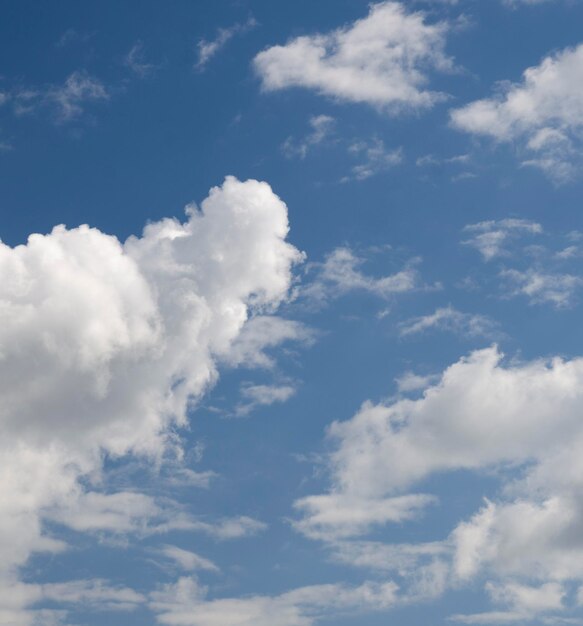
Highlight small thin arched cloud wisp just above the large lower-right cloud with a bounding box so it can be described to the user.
[399,306,496,337]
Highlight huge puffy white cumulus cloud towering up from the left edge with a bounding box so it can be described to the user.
[0,177,302,620]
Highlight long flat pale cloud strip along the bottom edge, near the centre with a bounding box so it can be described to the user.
[150,577,396,626]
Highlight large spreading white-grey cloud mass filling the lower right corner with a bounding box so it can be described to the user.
[295,347,583,623]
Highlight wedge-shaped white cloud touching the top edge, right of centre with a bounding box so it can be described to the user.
[254,2,453,113]
